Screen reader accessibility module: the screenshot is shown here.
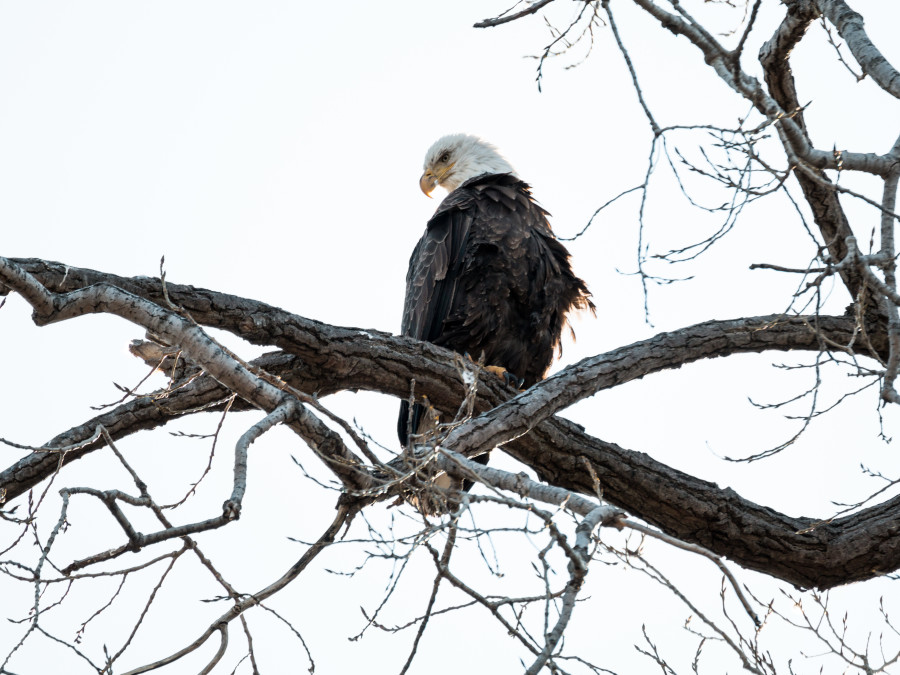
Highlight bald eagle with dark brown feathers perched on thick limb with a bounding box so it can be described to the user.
[397,134,594,448]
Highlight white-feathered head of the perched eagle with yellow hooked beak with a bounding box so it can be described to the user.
[419,134,515,197]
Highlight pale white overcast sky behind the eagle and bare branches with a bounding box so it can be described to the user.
[0,0,900,675]
